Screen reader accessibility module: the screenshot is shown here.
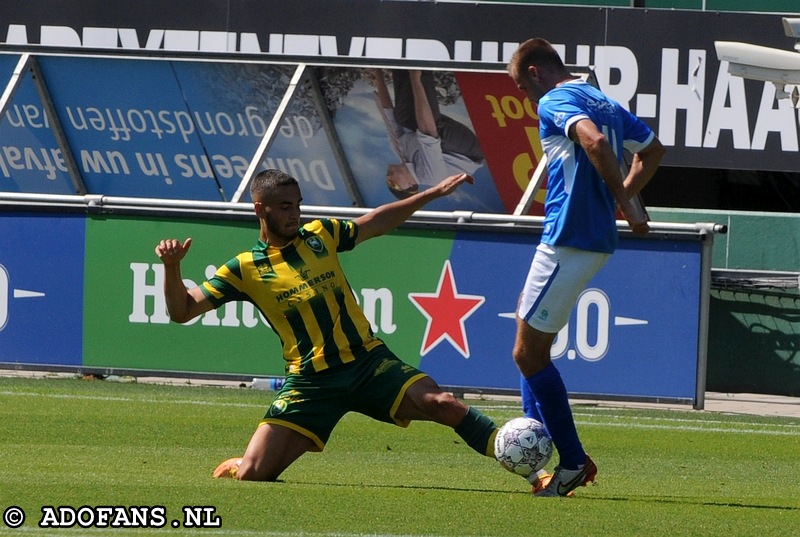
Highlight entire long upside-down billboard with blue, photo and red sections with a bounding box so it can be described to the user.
[0,56,541,210]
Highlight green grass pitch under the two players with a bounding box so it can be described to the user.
[0,377,800,537]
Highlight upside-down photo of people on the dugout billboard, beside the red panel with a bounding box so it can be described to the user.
[318,67,505,213]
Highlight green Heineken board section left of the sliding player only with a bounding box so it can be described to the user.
[84,217,283,375]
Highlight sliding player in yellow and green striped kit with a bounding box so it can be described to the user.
[155,170,497,481]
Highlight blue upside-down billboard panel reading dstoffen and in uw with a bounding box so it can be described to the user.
[41,57,231,201]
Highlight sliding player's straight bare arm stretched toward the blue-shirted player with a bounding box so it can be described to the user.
[355,173,475,243]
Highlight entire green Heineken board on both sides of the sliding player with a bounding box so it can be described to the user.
[83,217,454,376]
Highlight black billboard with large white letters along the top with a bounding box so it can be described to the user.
[0,0,800,171]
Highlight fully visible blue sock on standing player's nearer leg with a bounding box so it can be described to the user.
[523,363,586,470]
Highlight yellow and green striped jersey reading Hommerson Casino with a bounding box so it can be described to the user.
[201,219,383,374]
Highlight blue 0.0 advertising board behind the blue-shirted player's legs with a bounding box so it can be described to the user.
[418,232,702,399]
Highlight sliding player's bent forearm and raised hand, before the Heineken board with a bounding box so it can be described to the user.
[155,238,213,323]
